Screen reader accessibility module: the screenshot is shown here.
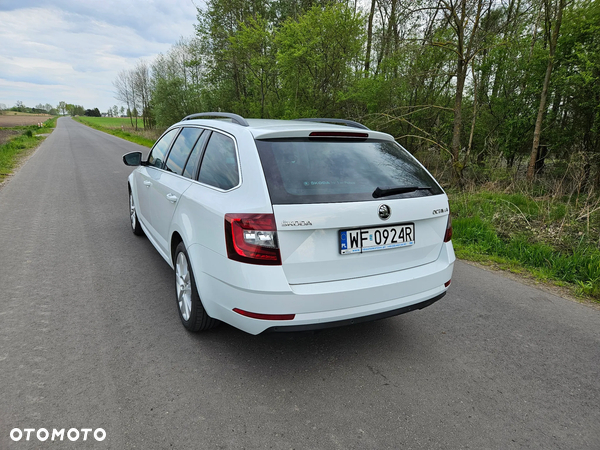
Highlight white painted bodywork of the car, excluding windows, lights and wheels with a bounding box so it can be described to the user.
[126,113,455,334]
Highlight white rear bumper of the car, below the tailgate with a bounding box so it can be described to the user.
[188,243,455,334]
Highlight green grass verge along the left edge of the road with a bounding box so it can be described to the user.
[0,117,57,181]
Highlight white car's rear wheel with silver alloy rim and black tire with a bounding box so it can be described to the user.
[174,242,219,332]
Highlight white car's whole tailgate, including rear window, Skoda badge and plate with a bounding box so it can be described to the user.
[256,136,449,284]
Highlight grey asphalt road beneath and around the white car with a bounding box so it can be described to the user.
[0,118,600,450]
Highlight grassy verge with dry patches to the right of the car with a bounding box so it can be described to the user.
[449,192,600,301]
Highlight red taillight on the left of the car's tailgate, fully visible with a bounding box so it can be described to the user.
[225,214,281,266]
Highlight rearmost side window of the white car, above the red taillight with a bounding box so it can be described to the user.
[198,133,240,191]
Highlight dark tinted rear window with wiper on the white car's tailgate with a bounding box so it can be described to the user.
[256,139,443,205]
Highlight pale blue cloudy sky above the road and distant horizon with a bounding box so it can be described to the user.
[0,0,203,112]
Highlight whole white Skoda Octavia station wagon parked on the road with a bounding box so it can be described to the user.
[123,113,455,334]
